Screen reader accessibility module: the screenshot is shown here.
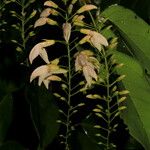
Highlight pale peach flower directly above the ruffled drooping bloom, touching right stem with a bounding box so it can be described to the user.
[79,29,108,51]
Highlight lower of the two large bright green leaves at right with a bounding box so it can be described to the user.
[115,51,150,150]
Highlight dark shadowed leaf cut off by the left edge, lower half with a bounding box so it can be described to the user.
[0,94,13,144]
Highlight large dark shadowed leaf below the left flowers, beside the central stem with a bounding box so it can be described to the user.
[27,86,58,150]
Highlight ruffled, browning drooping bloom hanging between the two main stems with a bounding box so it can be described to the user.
[75,50,100,87]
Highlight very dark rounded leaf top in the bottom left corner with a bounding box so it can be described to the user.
[0,141,25,150]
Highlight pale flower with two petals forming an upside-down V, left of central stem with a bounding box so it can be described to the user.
[29,40,55,64]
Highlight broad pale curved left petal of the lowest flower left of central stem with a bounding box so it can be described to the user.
[30,65,49,82]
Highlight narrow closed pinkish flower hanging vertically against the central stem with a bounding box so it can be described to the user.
[63,22,71,43]
